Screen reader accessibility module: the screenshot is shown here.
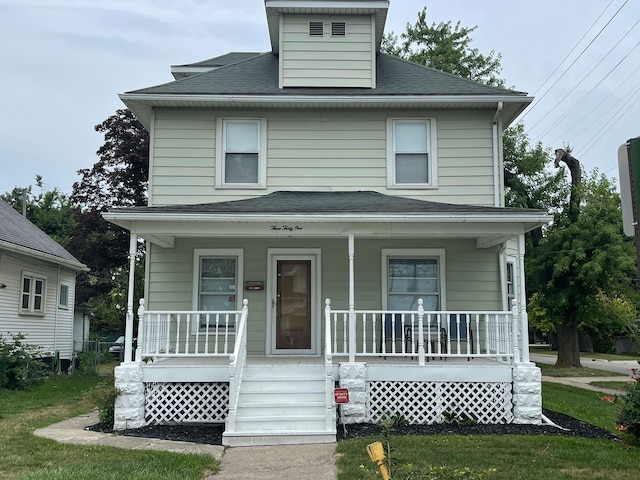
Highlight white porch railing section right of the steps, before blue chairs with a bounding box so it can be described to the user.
[325,299,519,365]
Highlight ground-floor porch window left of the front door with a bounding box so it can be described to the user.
[194,249,243,330]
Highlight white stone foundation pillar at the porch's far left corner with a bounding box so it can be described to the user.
[113,362,146,430]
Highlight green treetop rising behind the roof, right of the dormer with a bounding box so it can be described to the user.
[381,7,505,86]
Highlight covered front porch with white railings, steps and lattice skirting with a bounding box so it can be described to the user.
[105,192,546,445]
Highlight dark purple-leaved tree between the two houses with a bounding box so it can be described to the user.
[68,109,149,328]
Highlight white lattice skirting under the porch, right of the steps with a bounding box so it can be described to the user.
[366,381,514,424]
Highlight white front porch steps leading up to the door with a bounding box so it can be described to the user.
[222,365,336,447]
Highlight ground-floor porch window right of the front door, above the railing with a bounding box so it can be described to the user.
[382,249,444,311]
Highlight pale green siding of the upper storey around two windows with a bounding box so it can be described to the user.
[150,109,494,206]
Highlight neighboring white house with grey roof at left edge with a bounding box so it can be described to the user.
[0,199,86,367]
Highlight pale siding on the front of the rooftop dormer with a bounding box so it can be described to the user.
[280,15,375,88]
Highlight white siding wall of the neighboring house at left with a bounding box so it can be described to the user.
[0,252,75,359]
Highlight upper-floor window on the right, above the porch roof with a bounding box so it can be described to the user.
[387,119,437,188]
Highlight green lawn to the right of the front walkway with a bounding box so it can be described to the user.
[337,382,640,480]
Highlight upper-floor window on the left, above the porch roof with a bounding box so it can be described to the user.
[216,119,267,188]
